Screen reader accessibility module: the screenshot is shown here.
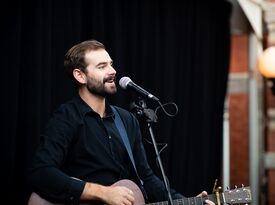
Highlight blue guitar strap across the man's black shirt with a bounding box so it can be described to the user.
[111,106,148,200]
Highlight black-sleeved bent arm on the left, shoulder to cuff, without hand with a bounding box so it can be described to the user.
[28,108,85,201]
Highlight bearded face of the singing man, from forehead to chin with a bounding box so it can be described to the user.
[85,49,117,97]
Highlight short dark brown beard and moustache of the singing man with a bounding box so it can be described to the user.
[86,76,117,97]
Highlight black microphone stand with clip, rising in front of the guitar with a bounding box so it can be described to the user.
[133,98,173,205]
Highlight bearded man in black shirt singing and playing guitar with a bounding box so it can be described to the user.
[30,40,216,205]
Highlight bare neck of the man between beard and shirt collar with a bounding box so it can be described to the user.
[78,88,105,118]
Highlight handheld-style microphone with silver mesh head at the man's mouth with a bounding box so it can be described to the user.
[119,77,159,101]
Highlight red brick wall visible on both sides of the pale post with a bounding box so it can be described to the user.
[228,33,275,205]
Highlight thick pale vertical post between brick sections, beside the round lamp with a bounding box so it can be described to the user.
[248,34,263,205]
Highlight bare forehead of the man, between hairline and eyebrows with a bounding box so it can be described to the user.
[85,49,112,65]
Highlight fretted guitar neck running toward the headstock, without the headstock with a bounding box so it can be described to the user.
[147,194,224,205]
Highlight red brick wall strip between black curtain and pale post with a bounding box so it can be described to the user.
[228,35,249,186]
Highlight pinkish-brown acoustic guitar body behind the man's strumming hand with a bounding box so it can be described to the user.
[28,179,145,205]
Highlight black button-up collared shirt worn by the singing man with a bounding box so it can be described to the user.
[30,97,182,201]
